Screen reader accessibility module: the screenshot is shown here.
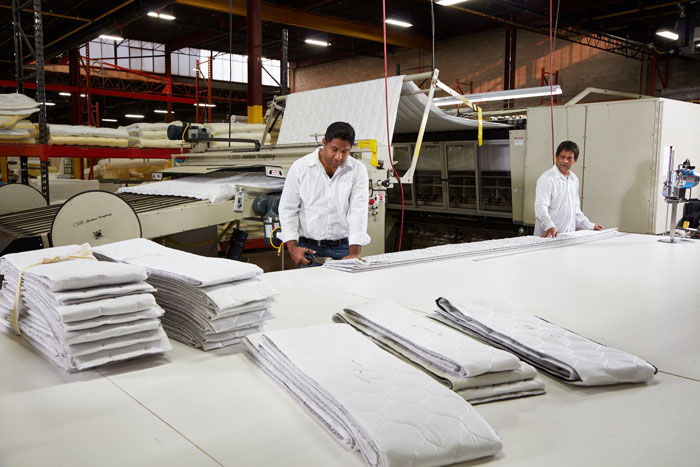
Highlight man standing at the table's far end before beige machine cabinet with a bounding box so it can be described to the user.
[535,141,603,237]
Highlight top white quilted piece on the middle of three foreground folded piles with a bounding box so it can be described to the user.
[343,300,520,377]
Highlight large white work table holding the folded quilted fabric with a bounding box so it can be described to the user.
[0,235,700,466]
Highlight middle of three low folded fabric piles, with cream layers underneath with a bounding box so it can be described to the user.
[334,300,545,404]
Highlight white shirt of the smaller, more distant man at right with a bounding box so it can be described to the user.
[535,165,595,235]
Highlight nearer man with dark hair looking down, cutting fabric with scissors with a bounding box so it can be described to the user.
[279,122,370,267]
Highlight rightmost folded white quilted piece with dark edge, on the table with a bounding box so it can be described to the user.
[436,294,657,386]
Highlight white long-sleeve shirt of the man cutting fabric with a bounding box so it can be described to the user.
[279,148,370,245]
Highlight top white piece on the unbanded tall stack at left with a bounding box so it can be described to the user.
[93,238,262,286]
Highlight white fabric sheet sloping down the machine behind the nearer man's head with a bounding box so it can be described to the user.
[277,76,403,146]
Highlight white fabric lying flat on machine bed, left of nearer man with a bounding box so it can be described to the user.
[117,173,284,203]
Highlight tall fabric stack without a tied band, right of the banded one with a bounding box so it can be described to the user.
[94,238,278,350]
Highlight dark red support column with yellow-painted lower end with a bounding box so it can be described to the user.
[247,0,262,123]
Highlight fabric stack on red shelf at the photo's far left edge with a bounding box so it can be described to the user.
[0,93,39,144]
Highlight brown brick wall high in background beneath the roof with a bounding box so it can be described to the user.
[294,29,642,102]
